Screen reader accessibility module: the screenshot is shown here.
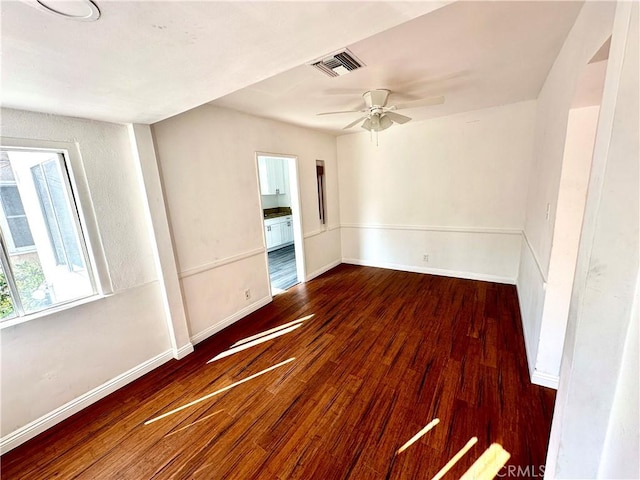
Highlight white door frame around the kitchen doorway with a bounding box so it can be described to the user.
[255,151,306,297]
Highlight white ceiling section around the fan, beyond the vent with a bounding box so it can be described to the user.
[212,1,582,134]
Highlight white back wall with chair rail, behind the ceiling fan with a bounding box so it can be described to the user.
[338,101,536,283]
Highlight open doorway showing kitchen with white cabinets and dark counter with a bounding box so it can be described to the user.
[256,153,304,295]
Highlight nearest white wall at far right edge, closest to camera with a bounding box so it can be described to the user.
[545,2,640,478]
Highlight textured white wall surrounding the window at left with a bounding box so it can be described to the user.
[0,109,170,448]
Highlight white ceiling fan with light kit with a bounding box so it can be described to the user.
[318,89,444,132]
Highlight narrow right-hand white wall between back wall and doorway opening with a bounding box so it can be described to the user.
[517,2,616,386]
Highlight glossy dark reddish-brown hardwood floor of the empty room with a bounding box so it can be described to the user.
[2,265,554,480]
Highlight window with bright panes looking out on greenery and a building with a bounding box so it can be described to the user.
[0,147,96,320]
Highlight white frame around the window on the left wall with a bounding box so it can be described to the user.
[0,137,113,329]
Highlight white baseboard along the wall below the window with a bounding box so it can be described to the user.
[0,350,173,454]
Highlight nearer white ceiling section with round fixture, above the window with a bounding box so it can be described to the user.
[0,0,449,123]
